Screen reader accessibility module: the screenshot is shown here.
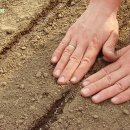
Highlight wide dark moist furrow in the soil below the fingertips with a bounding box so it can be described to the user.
[30,87,75,130]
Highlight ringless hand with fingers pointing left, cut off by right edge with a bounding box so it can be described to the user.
[81,45,130,104]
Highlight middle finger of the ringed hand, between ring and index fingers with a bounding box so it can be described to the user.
[58,45,86,84]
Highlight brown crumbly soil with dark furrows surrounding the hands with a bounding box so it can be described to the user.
[0,0,130,130]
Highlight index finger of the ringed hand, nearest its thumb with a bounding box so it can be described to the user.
[71,42,100,83]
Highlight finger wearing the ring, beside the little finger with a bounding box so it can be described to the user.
[53,41,76,78]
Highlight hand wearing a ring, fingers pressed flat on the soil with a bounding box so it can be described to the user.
[51,1,118,84]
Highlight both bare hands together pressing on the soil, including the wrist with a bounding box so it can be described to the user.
[51,0,130,104]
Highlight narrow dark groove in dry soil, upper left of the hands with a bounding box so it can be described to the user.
[0,0,59,54]
